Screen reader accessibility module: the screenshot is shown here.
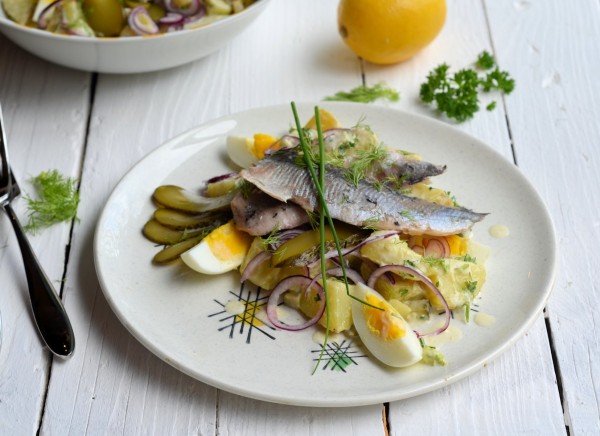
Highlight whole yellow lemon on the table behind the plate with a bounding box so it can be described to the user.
[338,0,446,64]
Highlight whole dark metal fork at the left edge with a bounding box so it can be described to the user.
[0,103,75,357]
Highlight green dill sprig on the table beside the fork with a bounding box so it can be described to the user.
[24,170,79,233]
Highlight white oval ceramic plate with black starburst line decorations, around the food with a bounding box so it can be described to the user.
[94,103,556,406]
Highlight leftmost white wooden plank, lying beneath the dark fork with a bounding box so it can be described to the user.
[0,36,90,434]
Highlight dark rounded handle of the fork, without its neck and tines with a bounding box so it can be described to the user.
[4,204,75,357]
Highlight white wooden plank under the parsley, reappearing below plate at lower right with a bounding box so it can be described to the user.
[358,1,564,434]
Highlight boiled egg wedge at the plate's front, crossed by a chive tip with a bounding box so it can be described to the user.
[352,284,423,367]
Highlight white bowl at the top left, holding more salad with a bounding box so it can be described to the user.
[0,0,269,73]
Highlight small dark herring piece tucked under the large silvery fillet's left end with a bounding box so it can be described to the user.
[231,189,308,236]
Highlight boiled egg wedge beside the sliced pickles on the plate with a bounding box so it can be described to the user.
[181,221,252,274]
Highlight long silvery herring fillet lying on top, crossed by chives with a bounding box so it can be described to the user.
[240,152,486,236]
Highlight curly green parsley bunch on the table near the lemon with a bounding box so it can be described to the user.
[420,51,515,122]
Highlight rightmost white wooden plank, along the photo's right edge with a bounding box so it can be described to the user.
[485,0,600,435]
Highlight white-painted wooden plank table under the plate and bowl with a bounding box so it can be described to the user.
[0,0,600,435]
